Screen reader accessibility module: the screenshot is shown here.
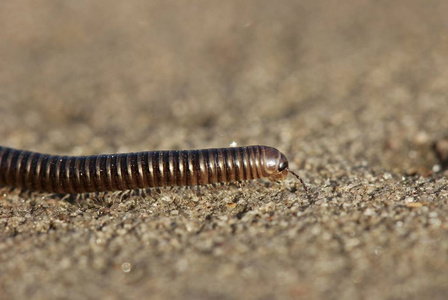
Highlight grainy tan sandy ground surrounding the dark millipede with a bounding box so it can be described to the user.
[0,0,448,299]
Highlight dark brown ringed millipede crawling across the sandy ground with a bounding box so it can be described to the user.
[0,146,307,194]
